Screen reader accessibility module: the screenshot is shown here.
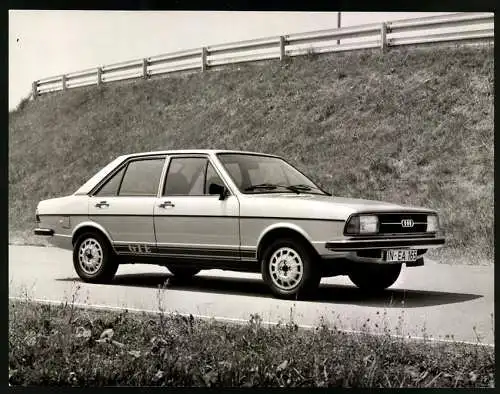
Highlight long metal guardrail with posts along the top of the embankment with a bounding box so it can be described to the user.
[32,13,494,98]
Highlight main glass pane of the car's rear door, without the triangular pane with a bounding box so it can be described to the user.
[118,158,165,196]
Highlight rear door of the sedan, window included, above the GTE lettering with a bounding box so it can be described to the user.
[89,155,165,255]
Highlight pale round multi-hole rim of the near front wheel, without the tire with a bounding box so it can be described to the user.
[269,247,304,290]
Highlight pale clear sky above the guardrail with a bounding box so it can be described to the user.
[9,10,460,110]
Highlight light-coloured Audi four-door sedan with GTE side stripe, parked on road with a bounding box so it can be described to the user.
[34,149,445,299]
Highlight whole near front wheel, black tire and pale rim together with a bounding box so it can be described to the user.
[261,238,321,299]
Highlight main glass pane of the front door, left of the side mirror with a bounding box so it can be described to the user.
[163,157,208,196]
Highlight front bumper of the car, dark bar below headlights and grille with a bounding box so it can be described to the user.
[325,237,445,252]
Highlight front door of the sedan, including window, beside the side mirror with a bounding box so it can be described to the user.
[154,155,240,260]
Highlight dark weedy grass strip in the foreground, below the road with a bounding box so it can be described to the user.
[9,300,495,388]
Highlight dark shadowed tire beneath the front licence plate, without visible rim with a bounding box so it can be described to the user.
[349,263,402,292]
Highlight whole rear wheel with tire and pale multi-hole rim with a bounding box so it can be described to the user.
[73,232,118,283]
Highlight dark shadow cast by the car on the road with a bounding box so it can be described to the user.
[58,273,483,308]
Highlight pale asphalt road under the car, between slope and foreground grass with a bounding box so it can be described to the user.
[9,245,494,344]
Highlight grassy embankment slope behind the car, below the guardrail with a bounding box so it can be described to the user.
[9,47,494,261]
